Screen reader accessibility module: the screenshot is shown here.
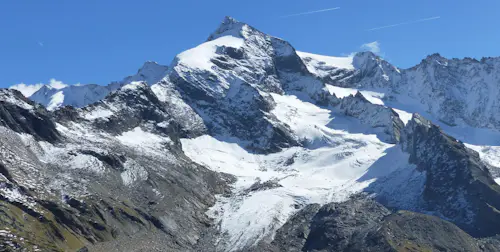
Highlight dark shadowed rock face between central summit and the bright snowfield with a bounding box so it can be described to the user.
[170,69,299,153]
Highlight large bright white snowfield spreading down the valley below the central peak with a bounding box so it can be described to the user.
[182,94,409,251]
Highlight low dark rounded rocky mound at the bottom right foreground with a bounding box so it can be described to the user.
[255,195,499,251]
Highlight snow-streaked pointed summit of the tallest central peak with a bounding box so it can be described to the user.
[169,18,336,103]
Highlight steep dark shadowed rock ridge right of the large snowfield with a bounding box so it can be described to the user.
[401,114,500,236]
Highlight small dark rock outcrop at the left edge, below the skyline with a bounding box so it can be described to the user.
[0,89,60,142]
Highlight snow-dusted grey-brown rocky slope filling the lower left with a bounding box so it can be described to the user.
[0,87,230,251]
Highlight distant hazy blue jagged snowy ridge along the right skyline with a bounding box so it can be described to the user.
[303,52,500,129]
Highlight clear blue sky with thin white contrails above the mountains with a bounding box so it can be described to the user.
[0,0,500,87]
